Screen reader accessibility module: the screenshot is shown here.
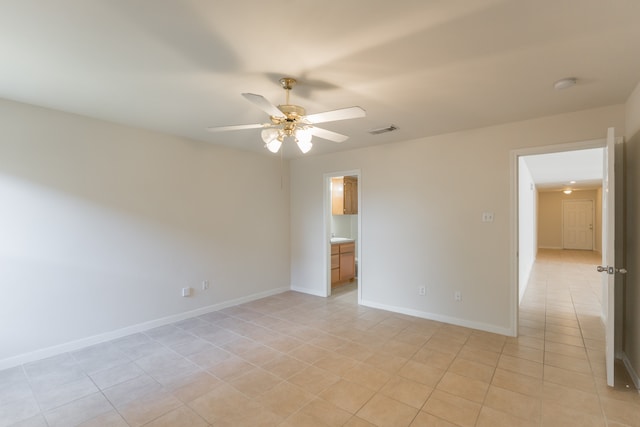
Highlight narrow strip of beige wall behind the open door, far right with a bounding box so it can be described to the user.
[623,84,640,388]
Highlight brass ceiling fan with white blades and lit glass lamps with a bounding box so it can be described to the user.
[207,77,366,153]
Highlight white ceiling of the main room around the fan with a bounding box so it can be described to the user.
[0,0,640,157]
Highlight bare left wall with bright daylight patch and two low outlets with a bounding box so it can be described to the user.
[0,100,289,369]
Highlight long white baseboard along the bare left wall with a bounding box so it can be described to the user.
[0,287,290,371]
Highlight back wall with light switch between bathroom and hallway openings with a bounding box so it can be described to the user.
[290,105,624,334]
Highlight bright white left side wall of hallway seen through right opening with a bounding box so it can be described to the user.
[518,157,538,302]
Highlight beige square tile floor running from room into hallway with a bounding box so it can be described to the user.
[0,251,640,427]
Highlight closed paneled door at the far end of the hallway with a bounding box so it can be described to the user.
[562,200,593,251]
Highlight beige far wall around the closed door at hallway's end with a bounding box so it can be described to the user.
[538,190,602,252]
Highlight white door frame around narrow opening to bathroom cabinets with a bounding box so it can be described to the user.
[322,169,364,304]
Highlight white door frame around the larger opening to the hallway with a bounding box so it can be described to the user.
[509,138,607,336]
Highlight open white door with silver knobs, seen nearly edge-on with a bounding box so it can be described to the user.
[598,128,617,387]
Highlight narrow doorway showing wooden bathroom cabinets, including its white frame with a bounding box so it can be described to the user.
[324,170,363,303]
